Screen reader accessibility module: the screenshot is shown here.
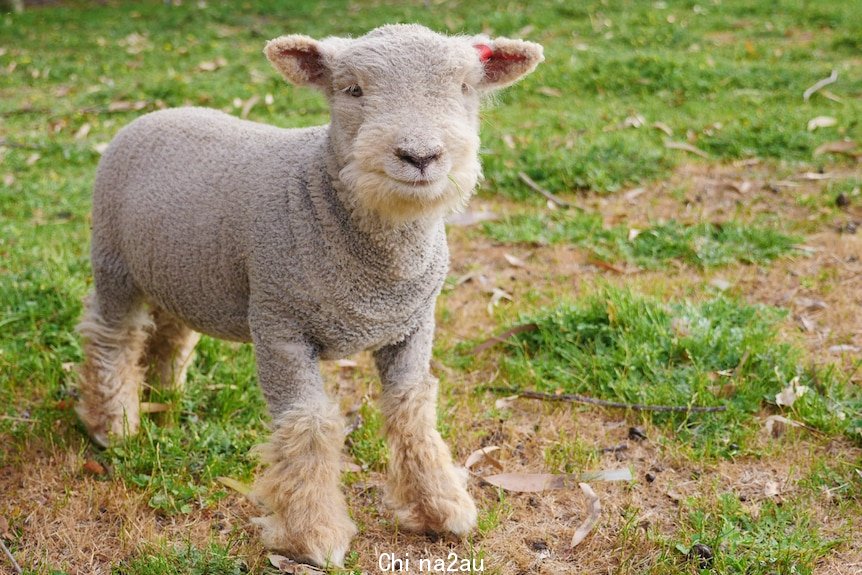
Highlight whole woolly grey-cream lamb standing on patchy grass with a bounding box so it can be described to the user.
[77,25,543,565]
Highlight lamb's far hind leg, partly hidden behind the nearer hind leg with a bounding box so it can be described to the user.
[144,306,201,391]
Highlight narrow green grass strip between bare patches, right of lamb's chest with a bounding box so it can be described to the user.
[484,212,800,269]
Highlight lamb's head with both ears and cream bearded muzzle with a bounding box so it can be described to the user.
[265,24,543,222]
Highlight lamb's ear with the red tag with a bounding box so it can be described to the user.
[473,38,545,90]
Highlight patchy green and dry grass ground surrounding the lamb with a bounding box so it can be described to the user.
[0,0,862,575]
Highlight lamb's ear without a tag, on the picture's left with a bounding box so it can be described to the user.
[263,34,332,90]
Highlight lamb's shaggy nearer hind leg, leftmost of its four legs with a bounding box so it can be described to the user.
[76,290,152,446]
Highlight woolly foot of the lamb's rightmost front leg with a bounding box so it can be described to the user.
[386,468,477,537]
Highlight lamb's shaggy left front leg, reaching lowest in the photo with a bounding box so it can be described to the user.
[252,337,356,566]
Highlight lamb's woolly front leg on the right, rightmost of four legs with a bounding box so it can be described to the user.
[375,320,476,535]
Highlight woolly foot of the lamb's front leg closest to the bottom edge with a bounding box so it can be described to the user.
[252,513,357,567]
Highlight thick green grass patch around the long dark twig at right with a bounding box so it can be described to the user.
[492,287,862,457]
